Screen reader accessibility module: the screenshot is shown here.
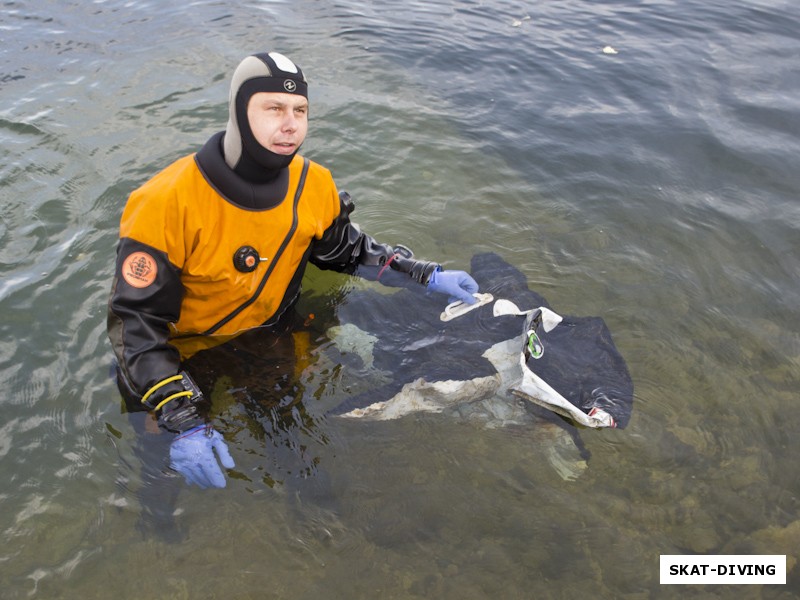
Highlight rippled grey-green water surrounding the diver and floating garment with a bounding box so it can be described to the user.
[0,0,800,599]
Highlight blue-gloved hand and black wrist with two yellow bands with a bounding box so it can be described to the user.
[142,371,235,489]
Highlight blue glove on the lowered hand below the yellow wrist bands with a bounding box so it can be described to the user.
[169,425,235,489]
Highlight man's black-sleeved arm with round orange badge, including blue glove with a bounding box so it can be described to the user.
[108,238,234,488]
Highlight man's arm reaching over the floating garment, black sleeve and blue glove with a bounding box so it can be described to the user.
[309,192,478,304]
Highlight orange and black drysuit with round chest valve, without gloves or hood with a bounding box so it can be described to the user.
[108,132,438,431]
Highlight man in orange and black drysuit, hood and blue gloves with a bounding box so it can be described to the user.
[108,53,478,487]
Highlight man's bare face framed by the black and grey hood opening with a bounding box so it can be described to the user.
[247,92,308,156]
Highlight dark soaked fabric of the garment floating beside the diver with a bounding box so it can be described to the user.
[332,253,633,428]
